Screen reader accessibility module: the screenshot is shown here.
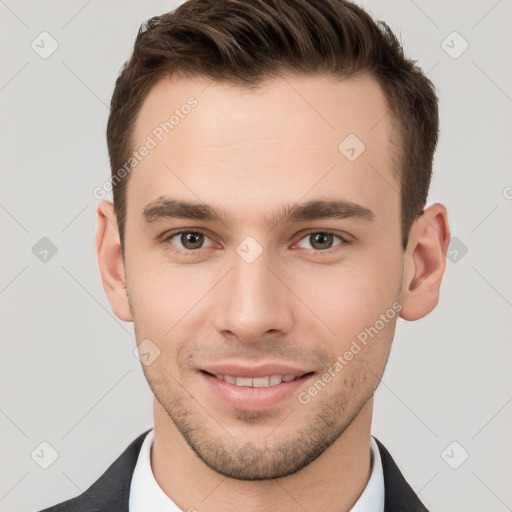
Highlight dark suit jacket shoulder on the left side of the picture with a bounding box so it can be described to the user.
[35,429,151,512]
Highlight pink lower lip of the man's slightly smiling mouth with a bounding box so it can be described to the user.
[200,372,312,411]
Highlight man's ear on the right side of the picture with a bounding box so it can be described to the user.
[400,203,450,320]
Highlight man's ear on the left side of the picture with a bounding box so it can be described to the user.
[96,201,133,322]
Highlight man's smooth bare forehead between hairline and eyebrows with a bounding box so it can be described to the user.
[127,75,399,230]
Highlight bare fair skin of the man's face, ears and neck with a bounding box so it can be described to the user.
[96,75,450,512]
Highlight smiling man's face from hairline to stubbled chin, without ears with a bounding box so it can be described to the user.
[125,76,403,479]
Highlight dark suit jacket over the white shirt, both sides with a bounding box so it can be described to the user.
[40,430,428,512]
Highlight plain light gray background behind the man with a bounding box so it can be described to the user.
[0,0,512,512]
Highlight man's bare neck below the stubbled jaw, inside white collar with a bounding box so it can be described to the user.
[151,398,373,512]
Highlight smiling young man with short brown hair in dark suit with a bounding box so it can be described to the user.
[38,0,450,512]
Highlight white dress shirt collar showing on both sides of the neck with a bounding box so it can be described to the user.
[129,429,384,512]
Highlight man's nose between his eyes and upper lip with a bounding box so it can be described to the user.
[215,251,297,343]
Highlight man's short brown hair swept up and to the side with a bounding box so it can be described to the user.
[107,0,439,255]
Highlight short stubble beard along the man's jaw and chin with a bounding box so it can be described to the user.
[146,368,378,481]
